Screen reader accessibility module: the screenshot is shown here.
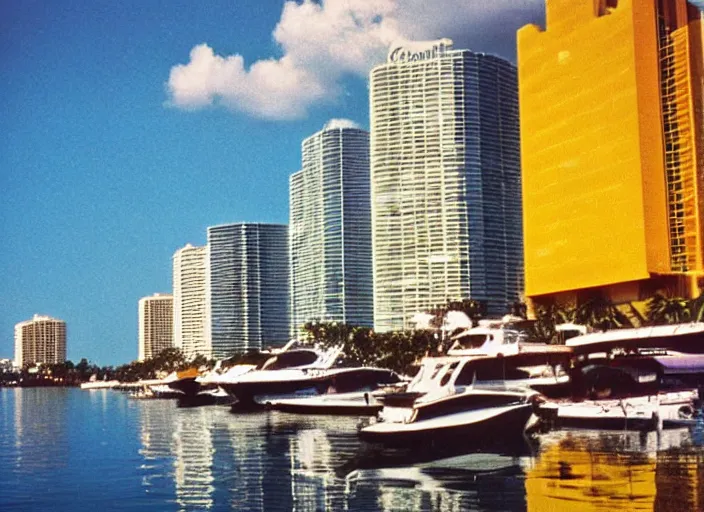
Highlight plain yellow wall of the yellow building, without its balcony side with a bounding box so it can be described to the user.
[518,0,669,296]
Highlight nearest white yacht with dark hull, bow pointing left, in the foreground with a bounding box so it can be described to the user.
[359,357,541,446]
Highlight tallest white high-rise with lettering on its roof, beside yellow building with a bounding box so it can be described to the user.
[370,39,523,331]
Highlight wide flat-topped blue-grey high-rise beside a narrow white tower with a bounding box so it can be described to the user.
[206,223,289,359]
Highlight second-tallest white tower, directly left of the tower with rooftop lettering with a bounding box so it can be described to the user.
[289,120,374,337]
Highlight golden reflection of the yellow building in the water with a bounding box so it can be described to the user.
[525,429,704,512]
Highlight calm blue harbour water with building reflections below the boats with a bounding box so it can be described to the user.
[0,388,704,512]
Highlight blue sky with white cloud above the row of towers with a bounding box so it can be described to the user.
[0,0,556,365]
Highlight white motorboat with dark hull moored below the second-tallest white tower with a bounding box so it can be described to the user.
[217,346,401,412]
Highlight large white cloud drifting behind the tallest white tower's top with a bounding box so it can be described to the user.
[167,0,544,119]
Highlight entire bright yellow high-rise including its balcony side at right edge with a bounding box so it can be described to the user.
[518,0,704,310]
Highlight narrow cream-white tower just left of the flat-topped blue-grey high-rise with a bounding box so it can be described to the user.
[173,244,211,359]
